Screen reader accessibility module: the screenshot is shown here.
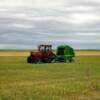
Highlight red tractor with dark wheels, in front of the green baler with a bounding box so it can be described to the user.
[27,45,56,63]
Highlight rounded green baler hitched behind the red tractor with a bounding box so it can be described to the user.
[56,45,75,62]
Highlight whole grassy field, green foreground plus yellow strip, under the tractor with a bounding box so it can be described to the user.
[0,51,100,100]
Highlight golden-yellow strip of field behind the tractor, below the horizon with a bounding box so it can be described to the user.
[0,50,100,56]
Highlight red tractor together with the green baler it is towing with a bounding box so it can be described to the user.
[27,45,75,63]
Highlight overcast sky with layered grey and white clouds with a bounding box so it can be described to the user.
[0,0,100,49]
